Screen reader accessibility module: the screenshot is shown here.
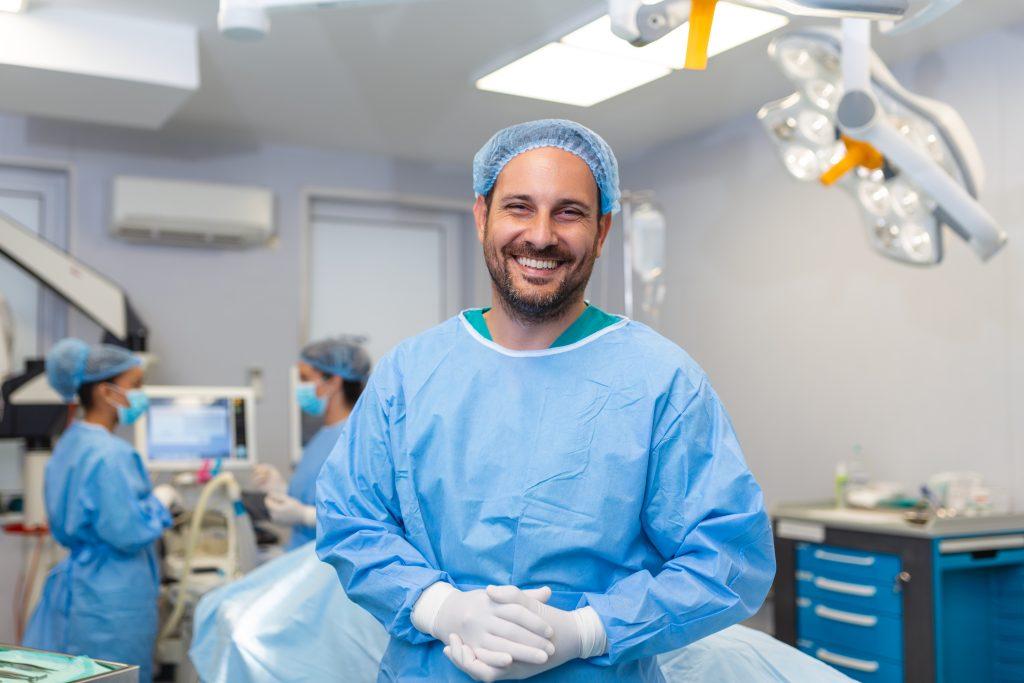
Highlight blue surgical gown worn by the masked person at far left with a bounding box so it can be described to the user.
[23,422,171,683]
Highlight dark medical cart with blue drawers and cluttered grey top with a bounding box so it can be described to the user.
[773,505,1024,683]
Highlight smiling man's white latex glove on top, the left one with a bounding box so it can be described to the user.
[413,582,555,668]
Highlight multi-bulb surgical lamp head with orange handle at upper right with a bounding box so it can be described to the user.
[758,28,1006,265]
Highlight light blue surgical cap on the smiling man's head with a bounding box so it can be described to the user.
[473,119,622,214]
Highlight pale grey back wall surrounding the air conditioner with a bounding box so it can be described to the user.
[0,113,472,475]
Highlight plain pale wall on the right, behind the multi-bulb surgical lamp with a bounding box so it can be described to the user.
[623,25,1024,507]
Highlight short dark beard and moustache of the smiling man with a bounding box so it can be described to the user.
[483,224,598,324]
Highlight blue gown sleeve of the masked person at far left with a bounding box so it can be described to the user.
[83,452,171,554]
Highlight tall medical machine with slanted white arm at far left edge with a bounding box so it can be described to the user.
[0,213,147,643]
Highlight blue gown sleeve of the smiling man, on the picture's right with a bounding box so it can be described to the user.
[581,377,775,665]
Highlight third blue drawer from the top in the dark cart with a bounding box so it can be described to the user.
[797,598,903,661]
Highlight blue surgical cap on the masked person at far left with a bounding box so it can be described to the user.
[46,337,141,400]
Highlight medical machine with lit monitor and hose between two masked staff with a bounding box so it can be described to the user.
[135,386,257,683]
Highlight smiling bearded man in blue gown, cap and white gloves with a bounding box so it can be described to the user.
[316,120,775,683]
